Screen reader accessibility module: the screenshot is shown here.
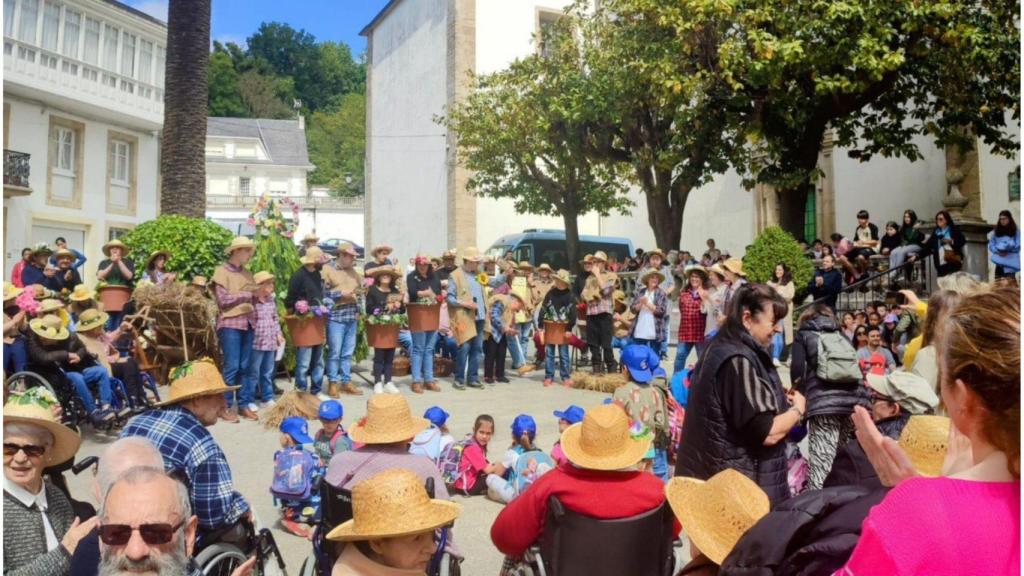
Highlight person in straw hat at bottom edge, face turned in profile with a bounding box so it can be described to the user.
[327,468,461,576]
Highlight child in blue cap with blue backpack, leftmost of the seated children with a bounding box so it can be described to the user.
[270,416,323,538]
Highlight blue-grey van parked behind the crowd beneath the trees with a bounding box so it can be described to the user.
[486,229,633,270]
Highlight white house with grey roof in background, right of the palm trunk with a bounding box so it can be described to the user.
[206,116,362,245]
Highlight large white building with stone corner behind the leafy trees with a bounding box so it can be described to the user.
[361,0,1019,256]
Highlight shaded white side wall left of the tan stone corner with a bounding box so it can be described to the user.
[367,0,449,257]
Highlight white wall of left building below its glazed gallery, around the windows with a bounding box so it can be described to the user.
[4,94,159,283]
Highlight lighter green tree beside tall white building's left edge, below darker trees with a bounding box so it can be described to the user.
[306,93,367,196]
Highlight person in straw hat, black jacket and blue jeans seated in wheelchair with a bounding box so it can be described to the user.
[26,315,118,425]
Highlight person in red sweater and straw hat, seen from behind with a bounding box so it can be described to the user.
[490,404,665,568]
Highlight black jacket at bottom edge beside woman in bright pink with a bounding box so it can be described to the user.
[719,486,889,576]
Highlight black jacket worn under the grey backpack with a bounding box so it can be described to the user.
[790,316,868,417]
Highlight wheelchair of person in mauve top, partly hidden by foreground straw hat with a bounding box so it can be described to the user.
[299,478,462,576]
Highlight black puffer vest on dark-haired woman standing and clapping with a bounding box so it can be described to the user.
[676,335,790,504]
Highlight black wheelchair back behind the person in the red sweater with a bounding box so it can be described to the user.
[513,496,678,576]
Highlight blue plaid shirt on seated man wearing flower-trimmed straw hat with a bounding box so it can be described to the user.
[121,406,249,530]
